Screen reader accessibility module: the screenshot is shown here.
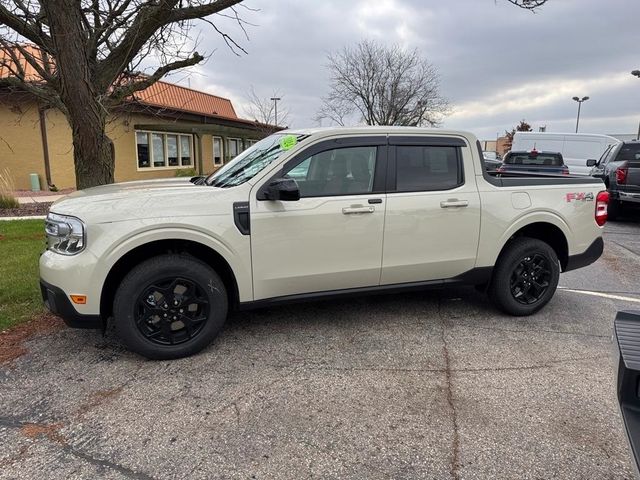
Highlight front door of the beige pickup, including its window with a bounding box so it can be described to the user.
[251,137,387,300]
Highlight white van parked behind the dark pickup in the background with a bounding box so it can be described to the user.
[511,132,620,175]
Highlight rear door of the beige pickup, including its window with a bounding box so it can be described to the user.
[381,136,480,285]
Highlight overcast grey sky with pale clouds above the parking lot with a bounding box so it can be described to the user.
[170,0,640,139]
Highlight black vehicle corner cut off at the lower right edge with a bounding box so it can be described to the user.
[613,311,640,474]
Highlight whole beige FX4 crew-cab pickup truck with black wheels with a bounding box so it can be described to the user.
[40,127,608,358]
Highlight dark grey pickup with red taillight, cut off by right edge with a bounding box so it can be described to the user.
[591,140,640,220]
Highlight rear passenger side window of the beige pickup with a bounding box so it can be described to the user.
[396,146,463,192]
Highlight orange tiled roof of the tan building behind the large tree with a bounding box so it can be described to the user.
[0,45,241,120]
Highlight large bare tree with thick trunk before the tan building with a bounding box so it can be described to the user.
[0,0,250,188]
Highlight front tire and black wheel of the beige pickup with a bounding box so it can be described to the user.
[113,254,228,360]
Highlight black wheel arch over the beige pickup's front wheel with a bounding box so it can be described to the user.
[100,239,240,319]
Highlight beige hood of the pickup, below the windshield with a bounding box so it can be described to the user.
[51,178,240,223]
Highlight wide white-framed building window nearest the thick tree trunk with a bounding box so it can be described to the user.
[136,132,193,170]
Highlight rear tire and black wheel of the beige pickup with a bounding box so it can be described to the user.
[489,237,560,316]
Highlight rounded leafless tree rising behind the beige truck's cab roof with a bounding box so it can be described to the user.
[316,40,449,126]
